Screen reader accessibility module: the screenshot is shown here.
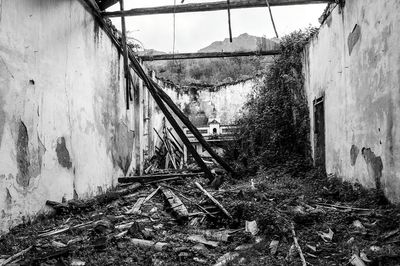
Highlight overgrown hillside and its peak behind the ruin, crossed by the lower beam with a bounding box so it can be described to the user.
[146,33,279,85]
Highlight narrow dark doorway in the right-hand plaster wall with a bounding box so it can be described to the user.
[314,97,325,169]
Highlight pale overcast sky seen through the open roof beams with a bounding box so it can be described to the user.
[108,0,326,52]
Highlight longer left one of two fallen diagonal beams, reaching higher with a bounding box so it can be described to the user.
[130,51,214,181]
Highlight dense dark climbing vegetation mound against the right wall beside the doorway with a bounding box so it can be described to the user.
[226,28,317,174]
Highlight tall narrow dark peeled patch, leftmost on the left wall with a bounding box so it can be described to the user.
[16,121,30,188]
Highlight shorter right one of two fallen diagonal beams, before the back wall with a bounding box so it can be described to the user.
[154,83,235,175]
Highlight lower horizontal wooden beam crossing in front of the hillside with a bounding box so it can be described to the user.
[140,49,280,61]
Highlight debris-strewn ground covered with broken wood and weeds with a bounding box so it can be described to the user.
[0,163,400,266]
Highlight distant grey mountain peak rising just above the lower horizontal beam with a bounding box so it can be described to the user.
[198,33,278,53]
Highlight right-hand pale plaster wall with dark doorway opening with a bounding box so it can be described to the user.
[304,0,400,202]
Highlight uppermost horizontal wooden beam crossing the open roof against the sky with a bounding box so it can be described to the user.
[102,0,334,17]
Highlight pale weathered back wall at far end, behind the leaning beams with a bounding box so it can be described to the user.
[148,75,259,158]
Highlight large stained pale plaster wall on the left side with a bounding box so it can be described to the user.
[0,0,137,233]
